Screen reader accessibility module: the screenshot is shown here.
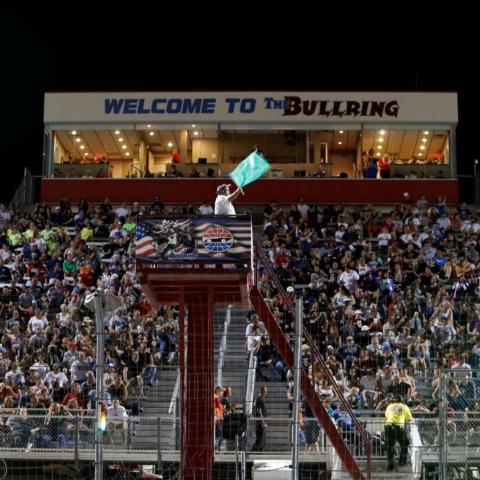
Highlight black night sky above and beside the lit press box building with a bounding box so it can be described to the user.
[0,7,480,202]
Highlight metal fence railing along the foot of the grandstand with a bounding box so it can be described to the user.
[0,412,480,480]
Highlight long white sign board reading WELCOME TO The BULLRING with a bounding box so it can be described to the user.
[44,92,458,124]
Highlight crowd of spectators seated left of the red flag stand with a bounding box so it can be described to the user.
[0,196,179,446]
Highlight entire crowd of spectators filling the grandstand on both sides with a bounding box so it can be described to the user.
[0,190,480,450]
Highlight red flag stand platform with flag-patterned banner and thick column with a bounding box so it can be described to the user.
[136,216,253,480]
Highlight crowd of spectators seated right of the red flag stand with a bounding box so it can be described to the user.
[253,195,480,414]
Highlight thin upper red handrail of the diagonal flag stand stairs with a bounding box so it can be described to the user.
[255,242,372,478]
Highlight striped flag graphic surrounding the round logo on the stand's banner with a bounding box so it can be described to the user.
[195,221,252,259]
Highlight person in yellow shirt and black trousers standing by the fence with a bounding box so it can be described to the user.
[385,395,412,471]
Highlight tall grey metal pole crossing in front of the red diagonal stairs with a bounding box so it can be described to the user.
[292,296,303,480]
